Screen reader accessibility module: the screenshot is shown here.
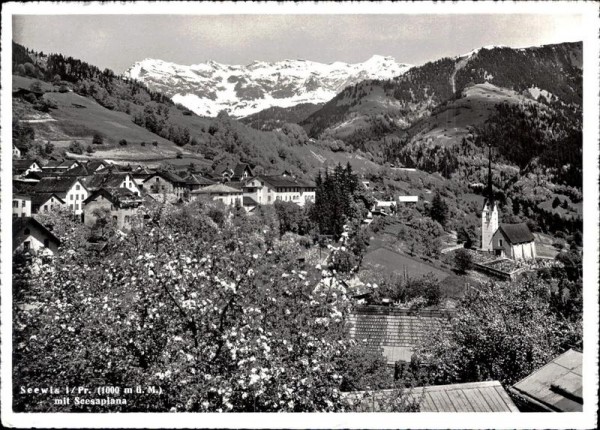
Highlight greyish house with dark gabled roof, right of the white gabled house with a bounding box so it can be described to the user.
[83,188,144,230]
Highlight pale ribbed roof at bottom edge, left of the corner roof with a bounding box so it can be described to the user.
[342,381,519,412]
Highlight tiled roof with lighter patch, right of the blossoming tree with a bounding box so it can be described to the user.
[349,306,452,364]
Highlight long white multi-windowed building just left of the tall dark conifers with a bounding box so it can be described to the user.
[243,175,316,206]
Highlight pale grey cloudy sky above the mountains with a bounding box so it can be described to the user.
[13,14,584,73]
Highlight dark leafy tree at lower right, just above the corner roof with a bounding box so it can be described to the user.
[417,278,581,386]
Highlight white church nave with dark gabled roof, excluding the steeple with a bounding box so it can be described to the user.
[492,223,537,260]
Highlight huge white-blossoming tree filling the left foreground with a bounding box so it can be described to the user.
[14,201,394,412]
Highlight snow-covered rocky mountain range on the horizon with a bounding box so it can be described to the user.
[125,55,411,117]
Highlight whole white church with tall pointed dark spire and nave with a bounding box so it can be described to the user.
[481,148,537,260]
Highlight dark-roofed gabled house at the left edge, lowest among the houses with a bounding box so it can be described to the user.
[12,217,60,257]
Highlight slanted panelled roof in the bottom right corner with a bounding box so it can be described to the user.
[512,349,583,412]
